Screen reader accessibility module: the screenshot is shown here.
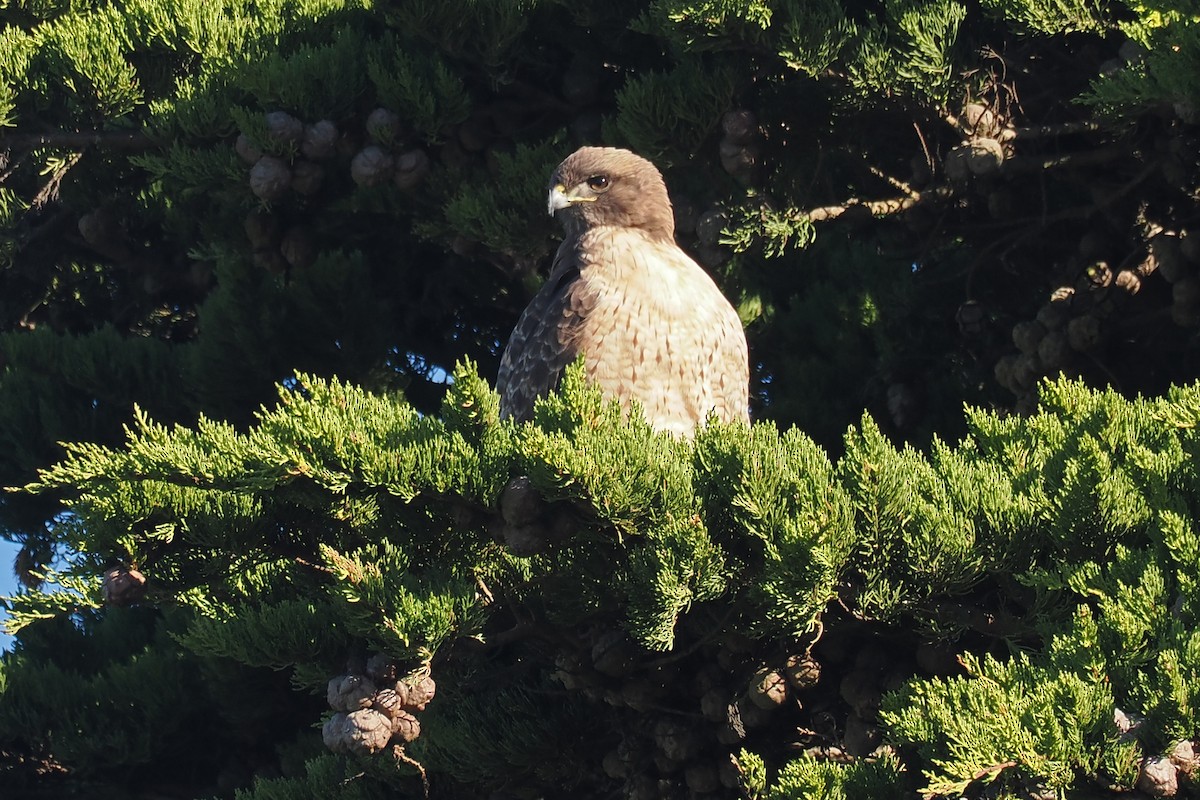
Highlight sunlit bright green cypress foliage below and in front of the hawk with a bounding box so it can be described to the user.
[11,365,1200,798]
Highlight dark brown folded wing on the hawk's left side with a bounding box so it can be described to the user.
[496,239,590,421]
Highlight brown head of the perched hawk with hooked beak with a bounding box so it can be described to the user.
[548,148,674,240]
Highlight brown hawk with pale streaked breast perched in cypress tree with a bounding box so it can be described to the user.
[496,148,749,437]
